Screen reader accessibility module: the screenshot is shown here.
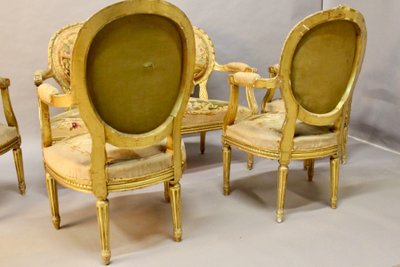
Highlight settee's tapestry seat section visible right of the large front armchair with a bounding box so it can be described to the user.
[182,98,251,128]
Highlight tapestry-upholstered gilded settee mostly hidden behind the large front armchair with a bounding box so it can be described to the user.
[34,22,258,160]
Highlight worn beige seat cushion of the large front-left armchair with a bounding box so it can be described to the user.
[43,134,186,181]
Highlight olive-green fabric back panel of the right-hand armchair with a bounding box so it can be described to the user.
[291,21,357,114]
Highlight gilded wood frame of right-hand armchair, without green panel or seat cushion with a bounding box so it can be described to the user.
[222,6,366,222]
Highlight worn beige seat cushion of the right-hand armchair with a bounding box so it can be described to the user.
[226,112,337,151]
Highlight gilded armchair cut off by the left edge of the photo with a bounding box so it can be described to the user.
[0,77,26,195]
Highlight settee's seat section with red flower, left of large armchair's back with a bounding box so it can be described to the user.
[51,108,88,141]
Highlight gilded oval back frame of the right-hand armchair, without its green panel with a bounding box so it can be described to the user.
[278,6,367,161]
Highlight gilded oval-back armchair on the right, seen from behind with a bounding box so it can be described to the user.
[222,6,366,222]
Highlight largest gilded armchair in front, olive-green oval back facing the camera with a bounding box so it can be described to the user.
[38,0,195,264]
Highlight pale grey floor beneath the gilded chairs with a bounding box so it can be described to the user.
[0,132,400,267]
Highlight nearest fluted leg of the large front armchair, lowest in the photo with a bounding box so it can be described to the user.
[96,199,111,265]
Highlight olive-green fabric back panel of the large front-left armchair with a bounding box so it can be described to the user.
[86,14,183,134]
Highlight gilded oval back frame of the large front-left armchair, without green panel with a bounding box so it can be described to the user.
[71,0,195,198]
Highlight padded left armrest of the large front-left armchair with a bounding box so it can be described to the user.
[37,83,74,108]
